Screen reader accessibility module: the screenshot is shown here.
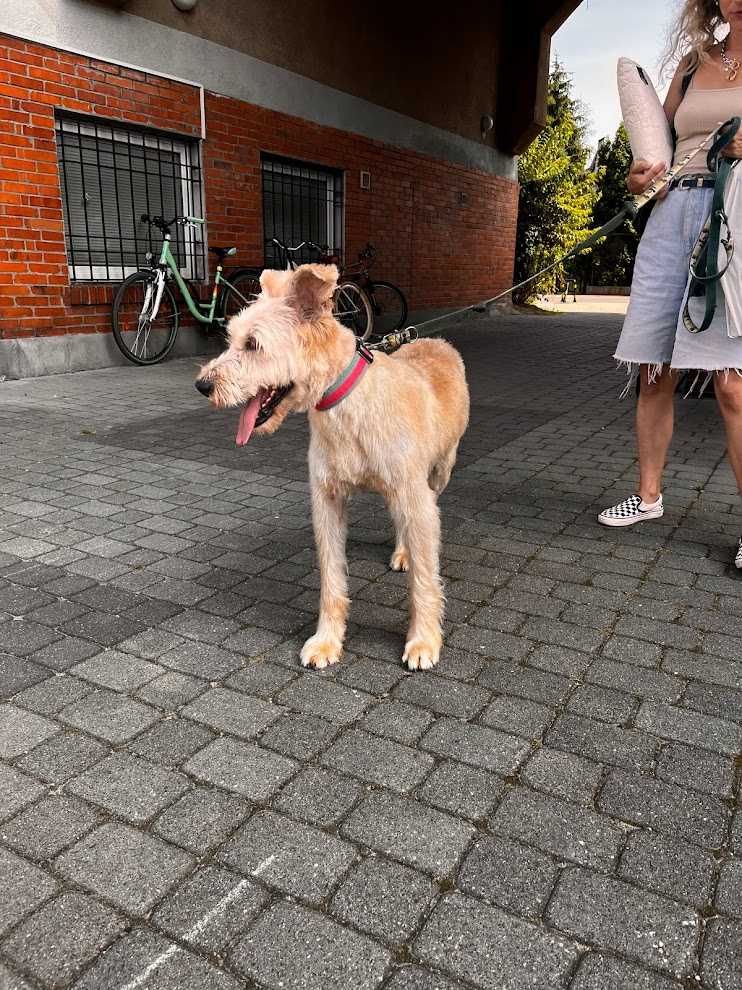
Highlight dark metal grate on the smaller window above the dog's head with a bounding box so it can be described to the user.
[261,155,343,268]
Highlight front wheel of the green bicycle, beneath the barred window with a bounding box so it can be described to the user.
[113,271,178,364]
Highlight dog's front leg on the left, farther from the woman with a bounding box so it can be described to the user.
[301,480,350,669]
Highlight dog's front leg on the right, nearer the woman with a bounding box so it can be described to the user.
[395,481,443,670]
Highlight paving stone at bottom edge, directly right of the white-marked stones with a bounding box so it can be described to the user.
[231,904,390,990]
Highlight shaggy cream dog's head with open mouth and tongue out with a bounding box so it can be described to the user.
[196,265,338,447]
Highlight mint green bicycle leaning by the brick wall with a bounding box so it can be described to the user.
[113,214,260,364]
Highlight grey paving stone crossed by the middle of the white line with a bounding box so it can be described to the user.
[152,866,269,955]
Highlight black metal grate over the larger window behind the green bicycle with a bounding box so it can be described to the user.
[56,115,206,281]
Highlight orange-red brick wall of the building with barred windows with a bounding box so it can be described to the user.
[0,37,517,346]
